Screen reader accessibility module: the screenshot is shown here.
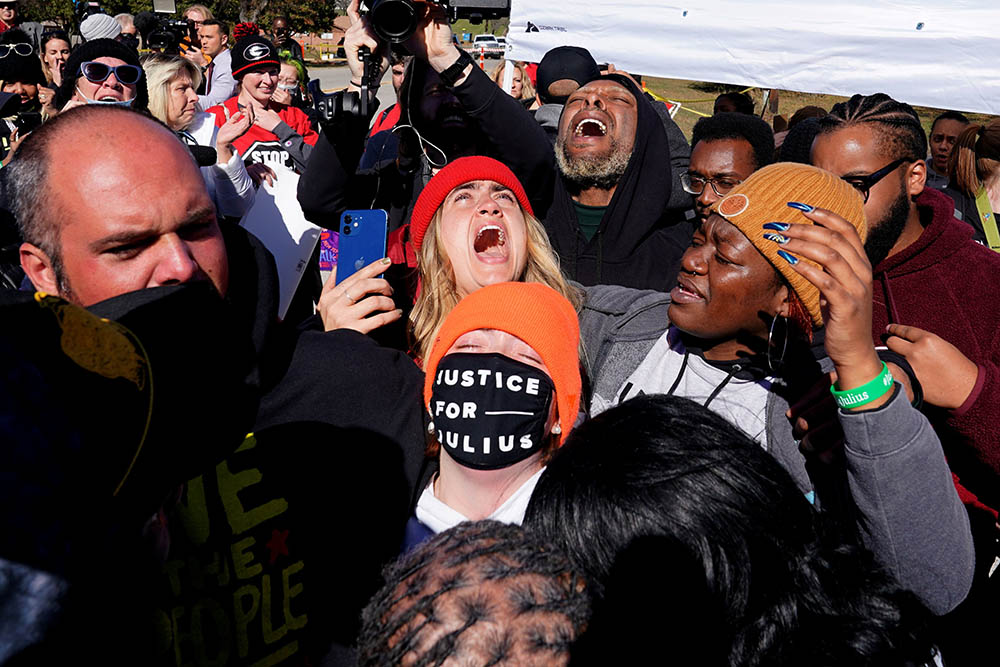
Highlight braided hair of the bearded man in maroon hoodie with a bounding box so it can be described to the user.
[819,93,927,162]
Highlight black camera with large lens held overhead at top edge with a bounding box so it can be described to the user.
[363,0,510,43]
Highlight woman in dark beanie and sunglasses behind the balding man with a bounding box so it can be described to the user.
[56,39,149,111]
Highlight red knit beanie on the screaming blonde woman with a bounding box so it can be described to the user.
[410,155,534,252]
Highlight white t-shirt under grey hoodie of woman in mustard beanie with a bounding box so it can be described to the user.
[591,327,773,449]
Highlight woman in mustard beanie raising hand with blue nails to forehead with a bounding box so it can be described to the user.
[580,163,975,613]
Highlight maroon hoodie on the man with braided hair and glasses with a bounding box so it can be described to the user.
[872,188,1000,507]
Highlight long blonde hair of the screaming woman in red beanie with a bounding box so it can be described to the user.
[410,207,582,360]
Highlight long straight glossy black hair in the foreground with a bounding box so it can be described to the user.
[524,395,931,667]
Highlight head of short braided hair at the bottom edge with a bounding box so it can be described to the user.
[358,521,590,667]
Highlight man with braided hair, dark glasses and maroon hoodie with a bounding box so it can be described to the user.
[812,93,1000,648]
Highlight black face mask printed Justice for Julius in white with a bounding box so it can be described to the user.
[430,353,555,470]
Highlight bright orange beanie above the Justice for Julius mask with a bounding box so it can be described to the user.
[424,282,582,445]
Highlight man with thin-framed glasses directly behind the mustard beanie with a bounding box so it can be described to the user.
[681,111,774,223]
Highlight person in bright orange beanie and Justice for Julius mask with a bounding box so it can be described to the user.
[406,282,582,547]
